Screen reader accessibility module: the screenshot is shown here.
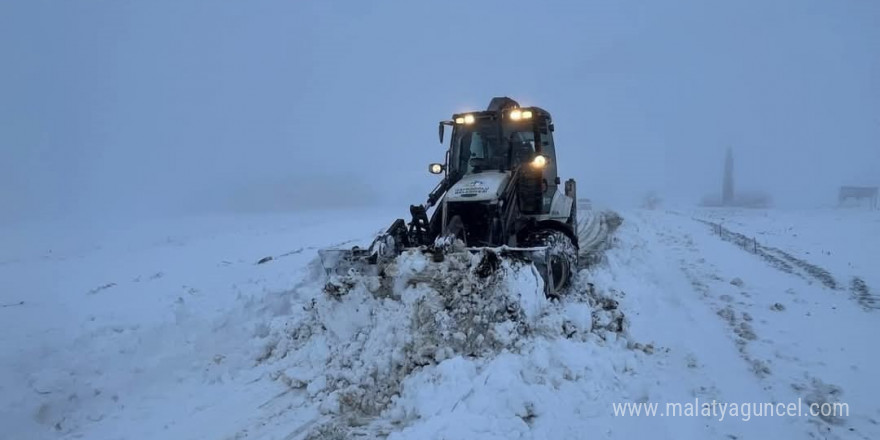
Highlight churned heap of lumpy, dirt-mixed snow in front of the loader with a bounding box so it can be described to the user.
[257,250,626,438]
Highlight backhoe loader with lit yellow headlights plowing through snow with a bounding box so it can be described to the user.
[319,97,578,297]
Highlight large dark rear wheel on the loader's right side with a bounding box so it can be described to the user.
[526,229,578,298]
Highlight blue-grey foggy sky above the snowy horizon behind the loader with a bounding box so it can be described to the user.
[0,0,880,227]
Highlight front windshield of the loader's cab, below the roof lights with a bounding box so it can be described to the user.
[452,120,535,175]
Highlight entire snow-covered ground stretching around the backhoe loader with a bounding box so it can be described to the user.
[0,210,880,439]
